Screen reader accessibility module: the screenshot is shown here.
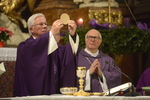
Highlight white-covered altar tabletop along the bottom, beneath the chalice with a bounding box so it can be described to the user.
[1,94,150,100]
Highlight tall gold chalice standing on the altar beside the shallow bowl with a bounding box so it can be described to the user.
[73,67,90,96]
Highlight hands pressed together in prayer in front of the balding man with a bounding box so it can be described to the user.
[89,59,102,77]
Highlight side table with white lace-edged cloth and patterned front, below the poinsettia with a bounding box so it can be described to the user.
[0,47,17,98]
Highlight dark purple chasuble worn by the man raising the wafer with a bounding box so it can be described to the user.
[14,33,76,96]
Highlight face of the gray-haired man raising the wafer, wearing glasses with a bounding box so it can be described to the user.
[30,16,48,38]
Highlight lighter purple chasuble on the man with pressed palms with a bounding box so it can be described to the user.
[77,49,122,92]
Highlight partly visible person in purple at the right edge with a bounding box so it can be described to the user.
[136,68,150,95]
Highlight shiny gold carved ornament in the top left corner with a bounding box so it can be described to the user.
[0,0,36,28]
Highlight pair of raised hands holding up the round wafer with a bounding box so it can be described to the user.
[50,19,77,36]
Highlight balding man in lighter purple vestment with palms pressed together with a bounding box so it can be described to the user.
[77,29,122,92]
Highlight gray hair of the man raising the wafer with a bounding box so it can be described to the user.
[27,13,46,34]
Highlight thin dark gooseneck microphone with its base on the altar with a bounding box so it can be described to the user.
[105,61,141,96]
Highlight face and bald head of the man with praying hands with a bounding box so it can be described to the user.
[85,29,102,53]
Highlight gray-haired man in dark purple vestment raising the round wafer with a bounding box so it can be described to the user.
[14,13,79,96]
